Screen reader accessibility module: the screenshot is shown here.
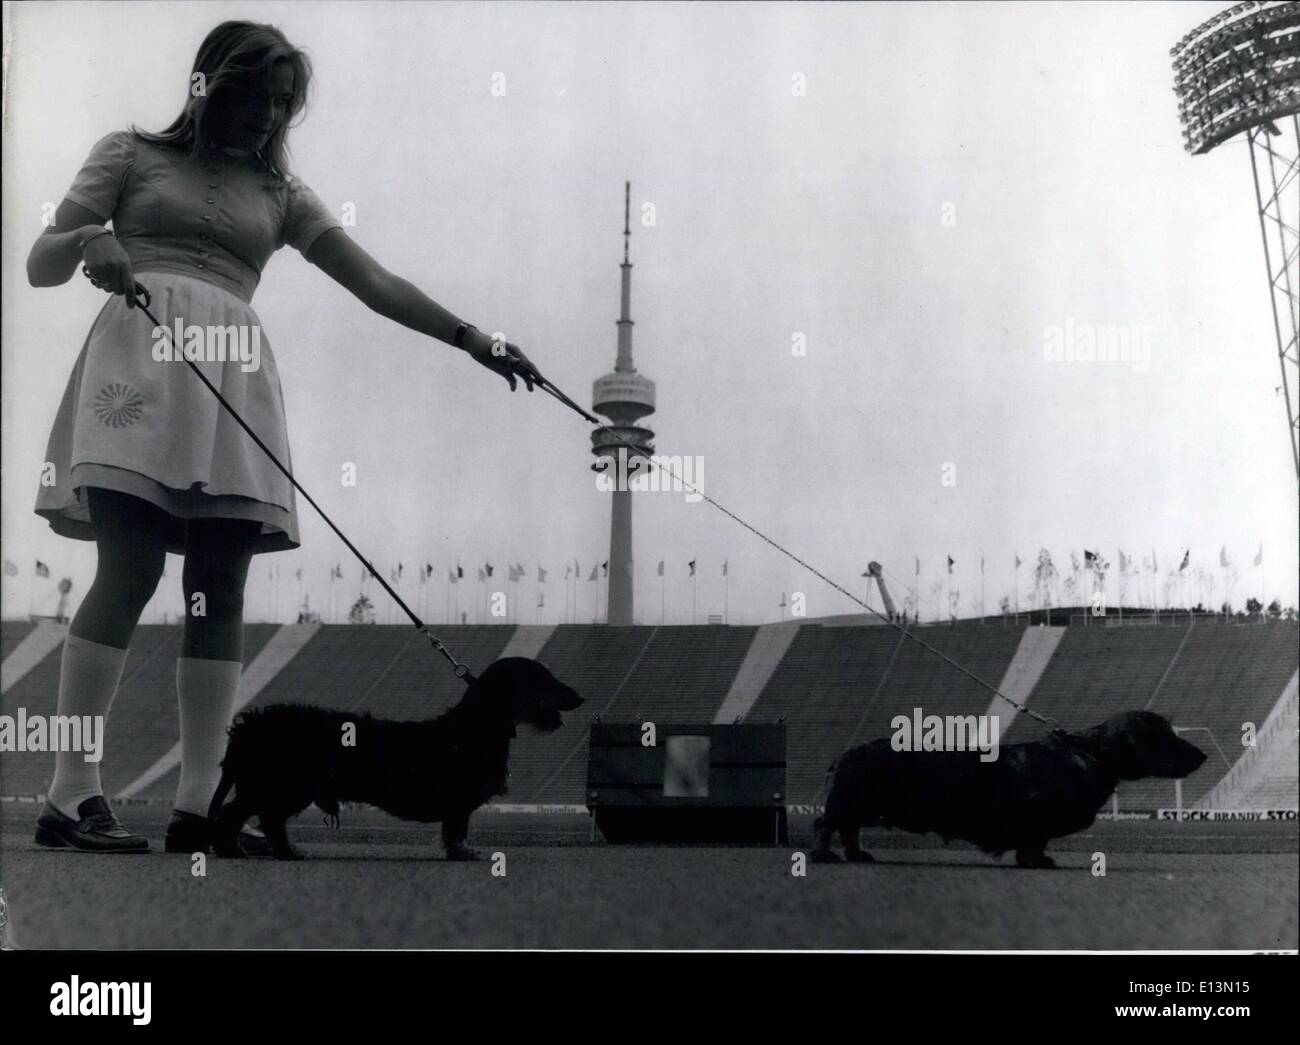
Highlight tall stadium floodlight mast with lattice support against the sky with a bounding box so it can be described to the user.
[1169,0,1300,480]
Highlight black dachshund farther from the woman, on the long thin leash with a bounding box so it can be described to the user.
[811,711,1205,868]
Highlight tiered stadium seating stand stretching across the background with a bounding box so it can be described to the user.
[0,617,1297,810]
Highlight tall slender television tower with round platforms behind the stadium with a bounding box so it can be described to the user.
[592,182,654,625]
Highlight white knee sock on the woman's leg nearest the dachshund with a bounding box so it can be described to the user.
[176,656,243,816]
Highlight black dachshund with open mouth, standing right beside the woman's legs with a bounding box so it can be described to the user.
[208,656,582,860]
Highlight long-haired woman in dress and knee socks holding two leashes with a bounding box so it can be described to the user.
[27,22,537,853]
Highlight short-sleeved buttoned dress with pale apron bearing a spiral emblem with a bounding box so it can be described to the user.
[36,131,339,551]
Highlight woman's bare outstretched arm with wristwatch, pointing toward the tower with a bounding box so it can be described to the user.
[307,229,537,391]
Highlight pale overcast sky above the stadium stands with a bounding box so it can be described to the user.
[0,0,1297,624]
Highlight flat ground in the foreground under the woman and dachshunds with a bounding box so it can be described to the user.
[0,803,1300,950]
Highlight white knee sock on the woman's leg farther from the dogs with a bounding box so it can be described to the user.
[48,634,126,820]
